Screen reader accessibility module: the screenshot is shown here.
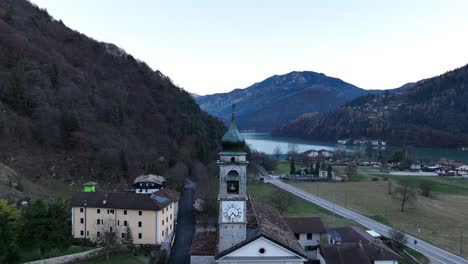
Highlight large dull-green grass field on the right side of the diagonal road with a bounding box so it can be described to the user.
[290,180,468,254]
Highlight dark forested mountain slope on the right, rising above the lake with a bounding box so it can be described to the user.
[273,65,468,147]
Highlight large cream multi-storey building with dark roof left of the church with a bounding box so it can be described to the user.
[71,189,179,245]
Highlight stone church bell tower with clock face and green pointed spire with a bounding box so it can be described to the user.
[218,106,248,252]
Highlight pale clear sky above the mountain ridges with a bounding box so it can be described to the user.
[32,0,468,95]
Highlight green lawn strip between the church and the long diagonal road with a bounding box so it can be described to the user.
[247,182,359,227]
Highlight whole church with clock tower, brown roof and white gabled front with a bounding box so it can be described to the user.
[190,113,307,264]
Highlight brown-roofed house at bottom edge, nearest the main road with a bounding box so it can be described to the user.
[319,227,403,264]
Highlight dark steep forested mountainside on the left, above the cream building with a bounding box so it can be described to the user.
[0,0,225,191]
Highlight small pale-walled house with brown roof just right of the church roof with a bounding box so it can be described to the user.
[286,217,327,259]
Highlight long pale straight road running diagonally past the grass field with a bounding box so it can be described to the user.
[254,165,468,264]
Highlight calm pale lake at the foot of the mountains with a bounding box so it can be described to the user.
[242,133,468,163]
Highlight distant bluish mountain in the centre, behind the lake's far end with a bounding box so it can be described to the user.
[196,71,367,131]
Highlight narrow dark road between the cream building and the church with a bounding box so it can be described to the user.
[169,184,195,264]
